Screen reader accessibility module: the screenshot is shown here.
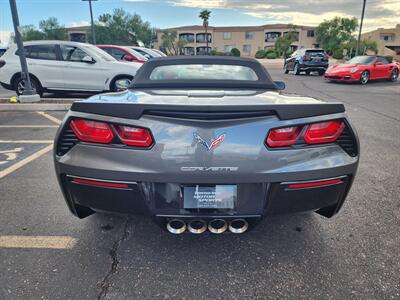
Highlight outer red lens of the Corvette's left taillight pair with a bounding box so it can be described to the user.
[70,119,114,144]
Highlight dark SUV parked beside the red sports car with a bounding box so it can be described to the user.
[284,48,329,75]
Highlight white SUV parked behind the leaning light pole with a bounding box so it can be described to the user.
[0,41,142,95]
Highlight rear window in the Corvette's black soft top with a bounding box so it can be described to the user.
[150,64,258,81]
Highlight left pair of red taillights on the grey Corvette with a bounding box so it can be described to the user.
[70,119,153,148]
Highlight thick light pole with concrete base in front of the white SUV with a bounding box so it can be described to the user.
[10,0,40,102]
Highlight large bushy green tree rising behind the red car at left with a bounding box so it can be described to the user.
[87,8,154,46]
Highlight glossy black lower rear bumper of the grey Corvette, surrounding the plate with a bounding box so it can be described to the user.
[55,174,354,218]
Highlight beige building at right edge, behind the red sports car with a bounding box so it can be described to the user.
[361,24,400,59]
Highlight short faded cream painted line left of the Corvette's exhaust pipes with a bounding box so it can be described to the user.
[0,235,77,249]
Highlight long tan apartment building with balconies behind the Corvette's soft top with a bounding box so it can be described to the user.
[154,24,319,57]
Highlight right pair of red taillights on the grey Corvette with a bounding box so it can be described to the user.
[266,120,346,148]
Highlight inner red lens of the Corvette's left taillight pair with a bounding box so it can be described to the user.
[115,125,153,147]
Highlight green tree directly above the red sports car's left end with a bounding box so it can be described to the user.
[315,17,358,53]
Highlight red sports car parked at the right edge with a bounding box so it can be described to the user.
[324,55,399,84]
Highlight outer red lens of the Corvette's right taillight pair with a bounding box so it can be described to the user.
[304,120,346,145]
